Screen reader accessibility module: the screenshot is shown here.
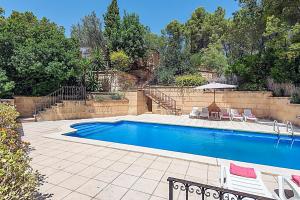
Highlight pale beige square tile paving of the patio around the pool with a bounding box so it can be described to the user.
[19,115,288,200]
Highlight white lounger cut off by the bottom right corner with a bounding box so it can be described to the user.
[278,176,300,200]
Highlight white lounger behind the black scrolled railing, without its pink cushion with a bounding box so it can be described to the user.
[221,166,274,199]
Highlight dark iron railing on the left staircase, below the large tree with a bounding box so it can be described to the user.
[33,86,87,115]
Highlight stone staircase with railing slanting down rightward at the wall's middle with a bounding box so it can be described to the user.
[143,86,181,115]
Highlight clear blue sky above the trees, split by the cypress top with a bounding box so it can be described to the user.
[0,0,239,35]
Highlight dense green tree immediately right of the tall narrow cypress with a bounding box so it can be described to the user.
[121,13,147,61]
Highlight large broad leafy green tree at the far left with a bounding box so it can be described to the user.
[0,11,80,95]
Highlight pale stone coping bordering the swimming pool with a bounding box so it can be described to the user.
[43,117,300,175]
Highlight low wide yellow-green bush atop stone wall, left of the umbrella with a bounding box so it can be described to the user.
[175,75,206,87]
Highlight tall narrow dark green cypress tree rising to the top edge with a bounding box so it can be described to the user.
[104,0,121,51]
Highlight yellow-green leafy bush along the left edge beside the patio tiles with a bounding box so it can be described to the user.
[0,104,42,200]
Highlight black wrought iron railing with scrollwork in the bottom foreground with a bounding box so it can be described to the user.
[168,177,275,200]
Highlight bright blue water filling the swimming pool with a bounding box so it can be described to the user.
[67,121,300,169]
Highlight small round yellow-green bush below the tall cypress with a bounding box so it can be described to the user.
[110,51,130,71]
